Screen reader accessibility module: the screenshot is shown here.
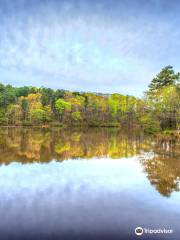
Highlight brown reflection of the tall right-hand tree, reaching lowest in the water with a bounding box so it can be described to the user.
[141,139,180,197]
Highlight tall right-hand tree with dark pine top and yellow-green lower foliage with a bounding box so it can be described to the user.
[146,66,180,129]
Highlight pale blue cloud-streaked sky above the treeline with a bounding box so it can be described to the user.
[0,0,180,96]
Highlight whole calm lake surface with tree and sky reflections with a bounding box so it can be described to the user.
[0,128,180,240]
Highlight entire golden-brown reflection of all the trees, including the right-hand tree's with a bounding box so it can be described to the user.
[0,128,180,196]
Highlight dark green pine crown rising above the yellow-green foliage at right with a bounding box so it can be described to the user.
[149,66,180,92]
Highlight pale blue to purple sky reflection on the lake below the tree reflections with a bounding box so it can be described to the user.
[0,157,180,240]
